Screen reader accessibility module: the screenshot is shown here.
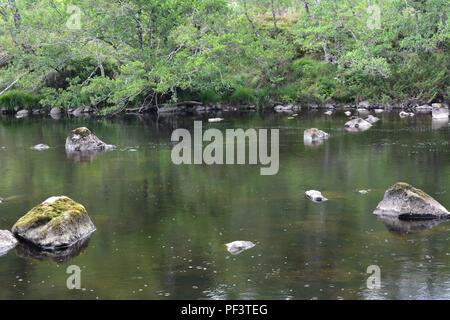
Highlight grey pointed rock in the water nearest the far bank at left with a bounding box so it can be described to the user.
[66,127,115,152]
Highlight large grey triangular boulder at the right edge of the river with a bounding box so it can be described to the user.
[374,182,450,220]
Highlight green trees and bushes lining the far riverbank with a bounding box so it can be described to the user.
[0,0,450,115]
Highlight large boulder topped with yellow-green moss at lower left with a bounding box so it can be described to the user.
[12,196,95,249]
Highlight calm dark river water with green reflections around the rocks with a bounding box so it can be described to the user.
[0,112,450,299]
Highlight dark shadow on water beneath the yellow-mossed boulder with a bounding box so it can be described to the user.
[16,235,92,263]
